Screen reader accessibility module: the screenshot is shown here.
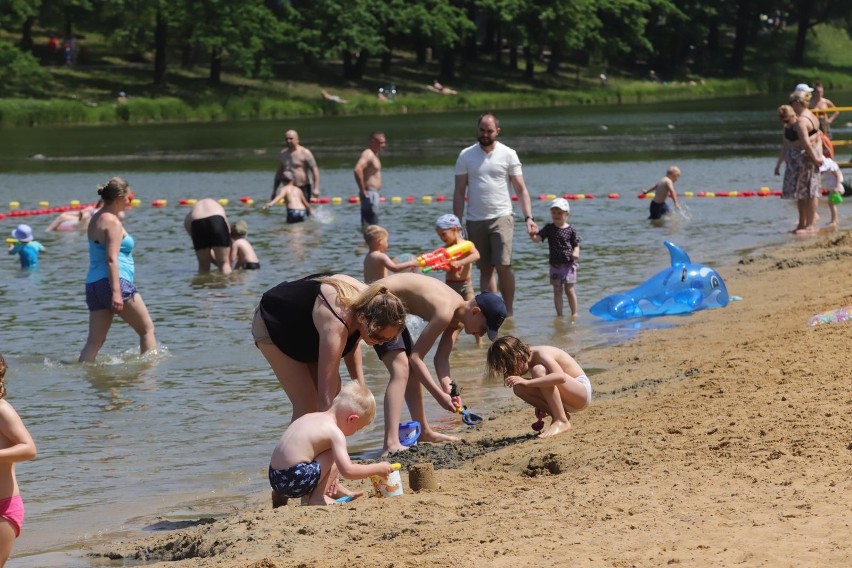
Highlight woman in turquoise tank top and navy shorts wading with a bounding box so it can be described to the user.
[79,177,157,363]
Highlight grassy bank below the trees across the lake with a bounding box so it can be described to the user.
[0,22,852,126]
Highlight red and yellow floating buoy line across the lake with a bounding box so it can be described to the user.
[0,187,828,220]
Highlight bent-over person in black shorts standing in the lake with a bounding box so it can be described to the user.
[183,197,231,274]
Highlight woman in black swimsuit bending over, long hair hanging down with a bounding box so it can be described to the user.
[252,274,406,420]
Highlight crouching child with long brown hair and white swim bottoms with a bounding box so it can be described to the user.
[486,335,592,438]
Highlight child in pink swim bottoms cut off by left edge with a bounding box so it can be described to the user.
[0,355,36,566]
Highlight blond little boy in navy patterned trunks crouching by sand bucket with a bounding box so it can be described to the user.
[269,382,392,508]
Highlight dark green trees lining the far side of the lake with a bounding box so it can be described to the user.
[0,0,852,95]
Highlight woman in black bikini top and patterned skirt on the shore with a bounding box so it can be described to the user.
[775,91,822,234]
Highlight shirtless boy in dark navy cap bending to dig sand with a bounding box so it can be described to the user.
[375,272,506,454]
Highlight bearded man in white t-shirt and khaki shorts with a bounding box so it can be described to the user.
[453,112,538,316]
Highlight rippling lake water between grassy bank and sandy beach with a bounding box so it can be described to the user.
[0,96,850,567]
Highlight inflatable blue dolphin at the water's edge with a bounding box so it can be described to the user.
[589,241,728,321]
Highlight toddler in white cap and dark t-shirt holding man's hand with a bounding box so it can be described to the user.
[530,197,580,318]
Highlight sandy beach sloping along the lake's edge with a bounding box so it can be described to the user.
[92,232,852,568]
